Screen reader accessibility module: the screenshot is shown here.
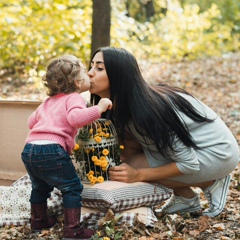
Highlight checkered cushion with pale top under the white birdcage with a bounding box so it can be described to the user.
[82,181,172,211]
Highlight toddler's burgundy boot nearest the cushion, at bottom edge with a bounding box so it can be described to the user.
[63,208,94,240]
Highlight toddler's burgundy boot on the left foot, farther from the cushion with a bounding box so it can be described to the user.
[30,203,56,232]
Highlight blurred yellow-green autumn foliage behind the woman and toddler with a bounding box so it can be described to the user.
[0,0,240,83]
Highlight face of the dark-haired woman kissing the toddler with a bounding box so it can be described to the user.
[88,52,110,98]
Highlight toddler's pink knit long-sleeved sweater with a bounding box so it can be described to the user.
[26,93,101,153]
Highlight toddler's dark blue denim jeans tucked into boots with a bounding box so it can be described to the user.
[22,143,83,208]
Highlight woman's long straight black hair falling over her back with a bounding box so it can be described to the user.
[91,47,213,155]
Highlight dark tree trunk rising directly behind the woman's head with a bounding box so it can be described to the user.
[91,0,111,54]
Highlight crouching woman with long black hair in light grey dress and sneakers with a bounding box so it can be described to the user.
[88,47,239,217]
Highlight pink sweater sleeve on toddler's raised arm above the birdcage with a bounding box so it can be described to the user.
[67,94,101,128]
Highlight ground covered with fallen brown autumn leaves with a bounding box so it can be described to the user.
[0,54,240,240]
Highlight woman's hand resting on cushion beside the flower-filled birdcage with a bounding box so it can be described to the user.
[109,163,140,183]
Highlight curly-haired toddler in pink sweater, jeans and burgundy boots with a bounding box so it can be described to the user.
[22,55,112,239]
